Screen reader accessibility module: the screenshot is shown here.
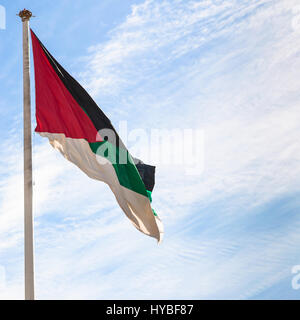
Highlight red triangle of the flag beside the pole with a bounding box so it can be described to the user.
[31,32,101,142]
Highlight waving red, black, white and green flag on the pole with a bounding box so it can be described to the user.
[31,30,163,242]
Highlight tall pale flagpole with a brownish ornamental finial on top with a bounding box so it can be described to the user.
[19,9,34,300]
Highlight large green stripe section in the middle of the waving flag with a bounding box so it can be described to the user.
[89,141,148,197]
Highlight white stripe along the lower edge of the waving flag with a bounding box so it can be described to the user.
[39,132,163,242]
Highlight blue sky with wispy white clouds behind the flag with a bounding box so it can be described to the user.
[0,0,300,300]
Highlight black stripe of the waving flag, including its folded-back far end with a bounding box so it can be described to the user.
[31,30,155,191]
